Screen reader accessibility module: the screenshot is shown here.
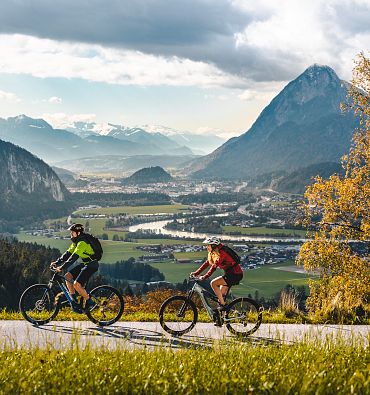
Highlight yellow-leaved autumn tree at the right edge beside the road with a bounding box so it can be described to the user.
[297,53,370,318]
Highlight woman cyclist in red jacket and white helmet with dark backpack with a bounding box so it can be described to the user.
[190,236,243,311]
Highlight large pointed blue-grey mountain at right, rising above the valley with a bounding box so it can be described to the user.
[188,64,358,179]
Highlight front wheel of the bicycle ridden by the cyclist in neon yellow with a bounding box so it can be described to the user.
[19,284,60,325]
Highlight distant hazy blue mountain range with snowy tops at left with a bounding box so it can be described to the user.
[0,115,190,163]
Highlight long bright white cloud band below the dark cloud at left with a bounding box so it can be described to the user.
[0,35,243,87]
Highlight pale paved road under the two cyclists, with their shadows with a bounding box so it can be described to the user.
[0,321,370,349]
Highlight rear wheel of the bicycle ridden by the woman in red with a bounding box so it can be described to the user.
[224,298,262,337]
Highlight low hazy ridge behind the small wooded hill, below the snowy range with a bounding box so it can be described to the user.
[56,155,195,177]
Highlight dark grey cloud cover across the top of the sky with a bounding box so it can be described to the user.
[0,0,370,81]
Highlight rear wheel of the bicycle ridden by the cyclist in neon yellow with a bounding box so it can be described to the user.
[86,285,124,326]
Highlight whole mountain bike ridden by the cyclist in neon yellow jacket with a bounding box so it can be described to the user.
[19,268,124,326]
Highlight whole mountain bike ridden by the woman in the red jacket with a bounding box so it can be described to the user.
[159,277,263,337]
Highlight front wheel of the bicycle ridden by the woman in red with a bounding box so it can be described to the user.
[159,295,198,336]
